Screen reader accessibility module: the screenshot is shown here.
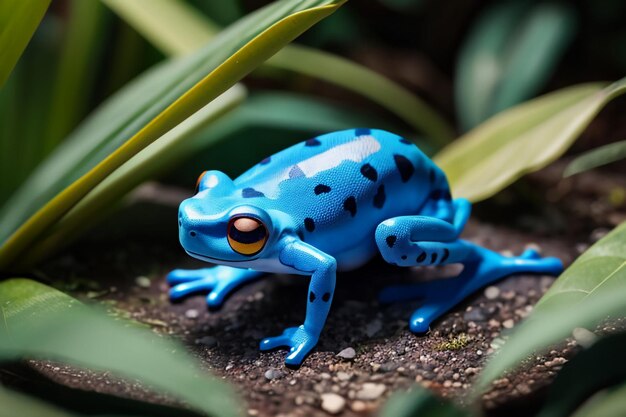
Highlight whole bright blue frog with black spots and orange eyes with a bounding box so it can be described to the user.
[167,129,563,365]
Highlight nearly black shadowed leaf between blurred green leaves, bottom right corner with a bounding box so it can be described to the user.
[538,333,626,417]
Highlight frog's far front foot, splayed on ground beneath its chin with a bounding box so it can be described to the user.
[167,265,263,308]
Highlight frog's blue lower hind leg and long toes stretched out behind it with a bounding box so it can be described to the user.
[379,239,563,333]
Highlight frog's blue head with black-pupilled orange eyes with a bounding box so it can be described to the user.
[178,171,272,263]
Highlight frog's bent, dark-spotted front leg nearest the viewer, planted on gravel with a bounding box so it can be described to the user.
[260,240,337,366]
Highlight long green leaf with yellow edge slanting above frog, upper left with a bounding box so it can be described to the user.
[0,0,344,269]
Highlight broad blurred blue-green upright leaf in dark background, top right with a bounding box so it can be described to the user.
[455,0,576,130]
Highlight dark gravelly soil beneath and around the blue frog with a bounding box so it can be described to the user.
[0,162,626,417]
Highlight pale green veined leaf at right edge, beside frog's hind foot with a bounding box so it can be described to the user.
[476,223,626,394]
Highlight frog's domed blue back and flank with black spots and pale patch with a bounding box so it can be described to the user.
[235,129,447,264]
